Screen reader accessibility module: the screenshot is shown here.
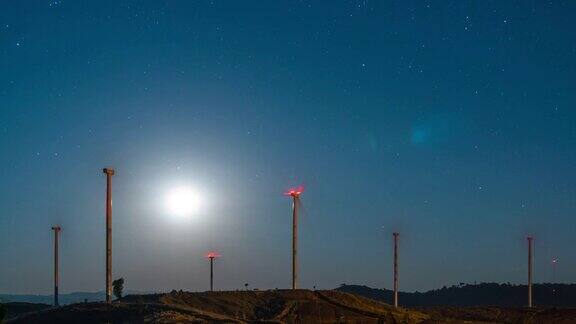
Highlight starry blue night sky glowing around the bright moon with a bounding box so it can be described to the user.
[0,0,576,293]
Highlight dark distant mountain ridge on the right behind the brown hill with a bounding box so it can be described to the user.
[336,283,576,307]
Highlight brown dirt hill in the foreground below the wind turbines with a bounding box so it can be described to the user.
[8,290,576,324]
